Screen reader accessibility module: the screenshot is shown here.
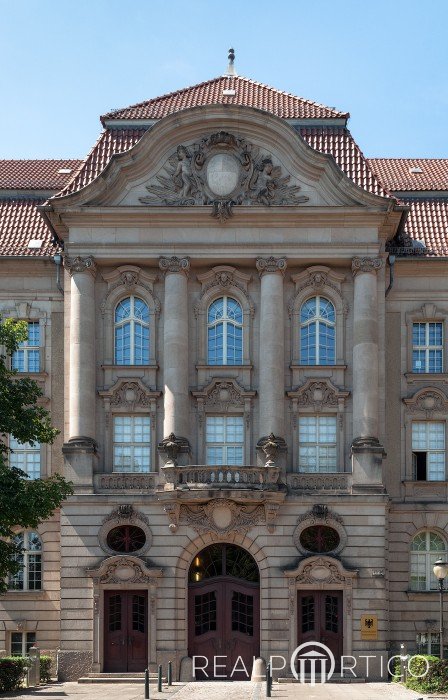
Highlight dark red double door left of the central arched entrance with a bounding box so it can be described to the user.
[104,591,148,673]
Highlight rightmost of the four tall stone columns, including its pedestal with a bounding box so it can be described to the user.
[352,257,383,485]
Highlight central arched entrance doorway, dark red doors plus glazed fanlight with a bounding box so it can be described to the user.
[188,544,260,680]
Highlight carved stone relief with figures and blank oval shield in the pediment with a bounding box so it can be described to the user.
[140,131,309,222]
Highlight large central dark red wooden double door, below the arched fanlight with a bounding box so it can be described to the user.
[188,577,260,681]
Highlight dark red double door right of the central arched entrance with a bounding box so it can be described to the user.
[298,591,342,670]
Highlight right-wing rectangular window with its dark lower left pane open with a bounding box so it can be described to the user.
[412,421,445,481]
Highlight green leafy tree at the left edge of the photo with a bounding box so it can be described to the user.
[0,319,73,592]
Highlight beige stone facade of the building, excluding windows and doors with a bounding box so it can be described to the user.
[0,89,448,679]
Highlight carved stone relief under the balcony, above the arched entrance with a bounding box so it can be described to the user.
[164,499,279,540]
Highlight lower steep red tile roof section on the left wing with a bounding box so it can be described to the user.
[0,197,56,257]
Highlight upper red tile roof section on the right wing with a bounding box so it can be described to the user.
[368,158,448,192]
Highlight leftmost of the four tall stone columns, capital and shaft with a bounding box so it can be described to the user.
[64,256,96,442]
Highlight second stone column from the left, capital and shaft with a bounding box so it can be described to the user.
[159,256,190,438]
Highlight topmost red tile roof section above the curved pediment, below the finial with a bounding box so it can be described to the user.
[101,75,349,124]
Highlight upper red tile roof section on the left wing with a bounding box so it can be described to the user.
[0,160,83,191]
